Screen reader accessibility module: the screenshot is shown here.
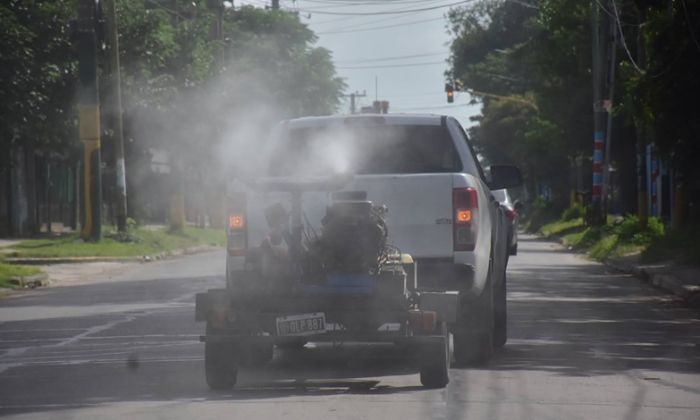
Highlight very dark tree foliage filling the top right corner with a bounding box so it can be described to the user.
[619,0,700,187]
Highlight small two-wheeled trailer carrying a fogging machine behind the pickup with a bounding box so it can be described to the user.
[195,179,459,389]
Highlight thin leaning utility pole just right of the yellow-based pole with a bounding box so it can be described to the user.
[102,0,127,232]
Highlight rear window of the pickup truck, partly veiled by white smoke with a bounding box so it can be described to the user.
[268,125,462,176]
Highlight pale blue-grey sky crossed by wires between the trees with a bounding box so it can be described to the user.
[235,0,480,127]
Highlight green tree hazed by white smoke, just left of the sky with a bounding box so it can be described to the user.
[110,0,344,223]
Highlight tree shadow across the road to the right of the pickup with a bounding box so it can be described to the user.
[488,239,700,376]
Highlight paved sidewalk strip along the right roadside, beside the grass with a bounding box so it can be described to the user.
[605,254,700,308]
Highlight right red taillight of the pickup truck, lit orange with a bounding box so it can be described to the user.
[452,188,479,251]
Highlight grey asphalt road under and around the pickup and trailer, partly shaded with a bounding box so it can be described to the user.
[0,237,700,420]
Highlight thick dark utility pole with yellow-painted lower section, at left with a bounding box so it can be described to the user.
[76,0,102,241]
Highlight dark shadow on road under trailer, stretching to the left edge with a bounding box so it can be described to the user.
[0,343,423,414]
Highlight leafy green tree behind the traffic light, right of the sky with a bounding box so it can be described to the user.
[448,0,591,204]
